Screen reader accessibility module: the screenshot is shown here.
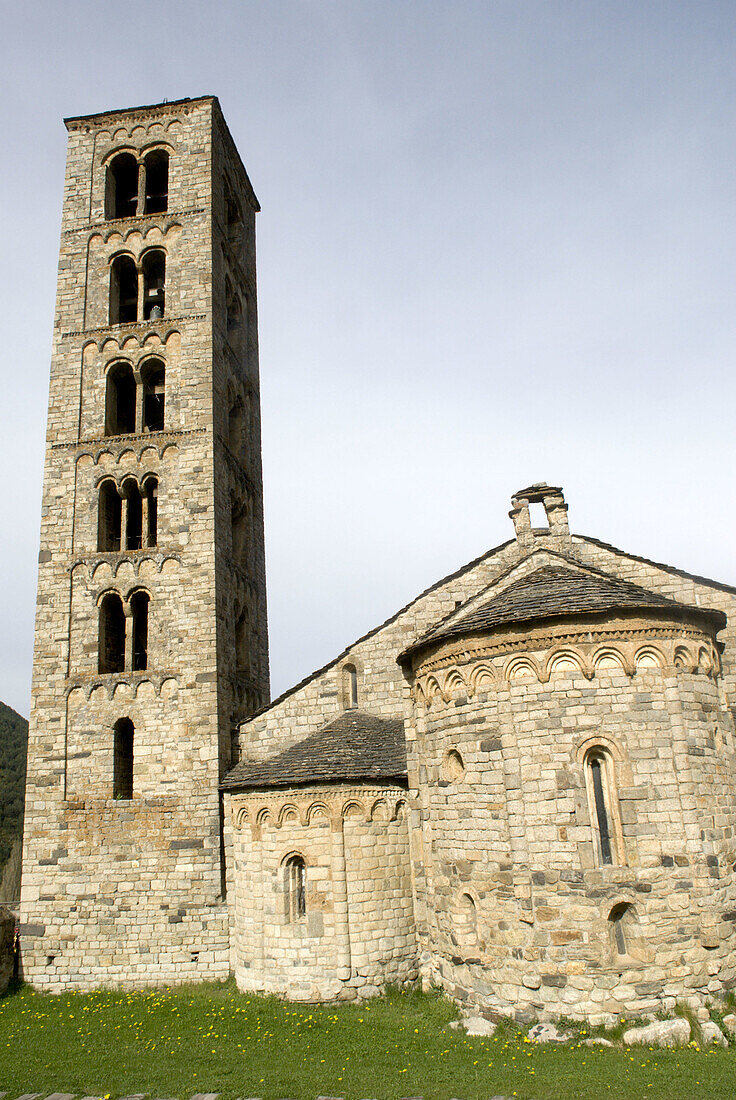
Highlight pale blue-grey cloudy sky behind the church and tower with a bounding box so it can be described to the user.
[0,0,736,715]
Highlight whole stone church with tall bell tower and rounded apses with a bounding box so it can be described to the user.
[15,97,736,1021]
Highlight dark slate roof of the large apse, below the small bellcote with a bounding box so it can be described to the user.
[402,565,726,657]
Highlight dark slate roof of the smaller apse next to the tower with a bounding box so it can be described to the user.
[221,711,406,790]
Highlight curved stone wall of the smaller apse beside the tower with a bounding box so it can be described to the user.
[227,787,417,1001]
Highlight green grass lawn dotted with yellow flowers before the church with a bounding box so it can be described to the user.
[0,982,736,1100]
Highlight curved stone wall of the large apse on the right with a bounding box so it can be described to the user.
[409,618,736,1020]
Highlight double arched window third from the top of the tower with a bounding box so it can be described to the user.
[105,359,166,436]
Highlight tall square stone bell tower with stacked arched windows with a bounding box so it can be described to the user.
[21,96,268,990]
